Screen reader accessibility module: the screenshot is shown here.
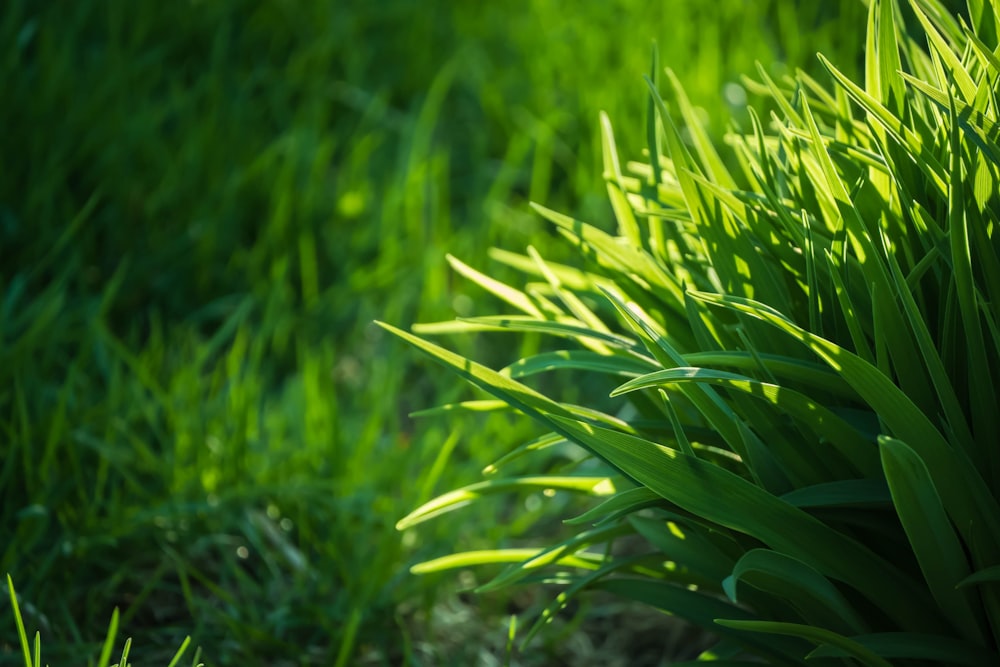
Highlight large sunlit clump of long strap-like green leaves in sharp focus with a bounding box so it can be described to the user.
[383,0,1000,667]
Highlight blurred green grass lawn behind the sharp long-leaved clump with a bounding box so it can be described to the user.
[0,0,865,665]
